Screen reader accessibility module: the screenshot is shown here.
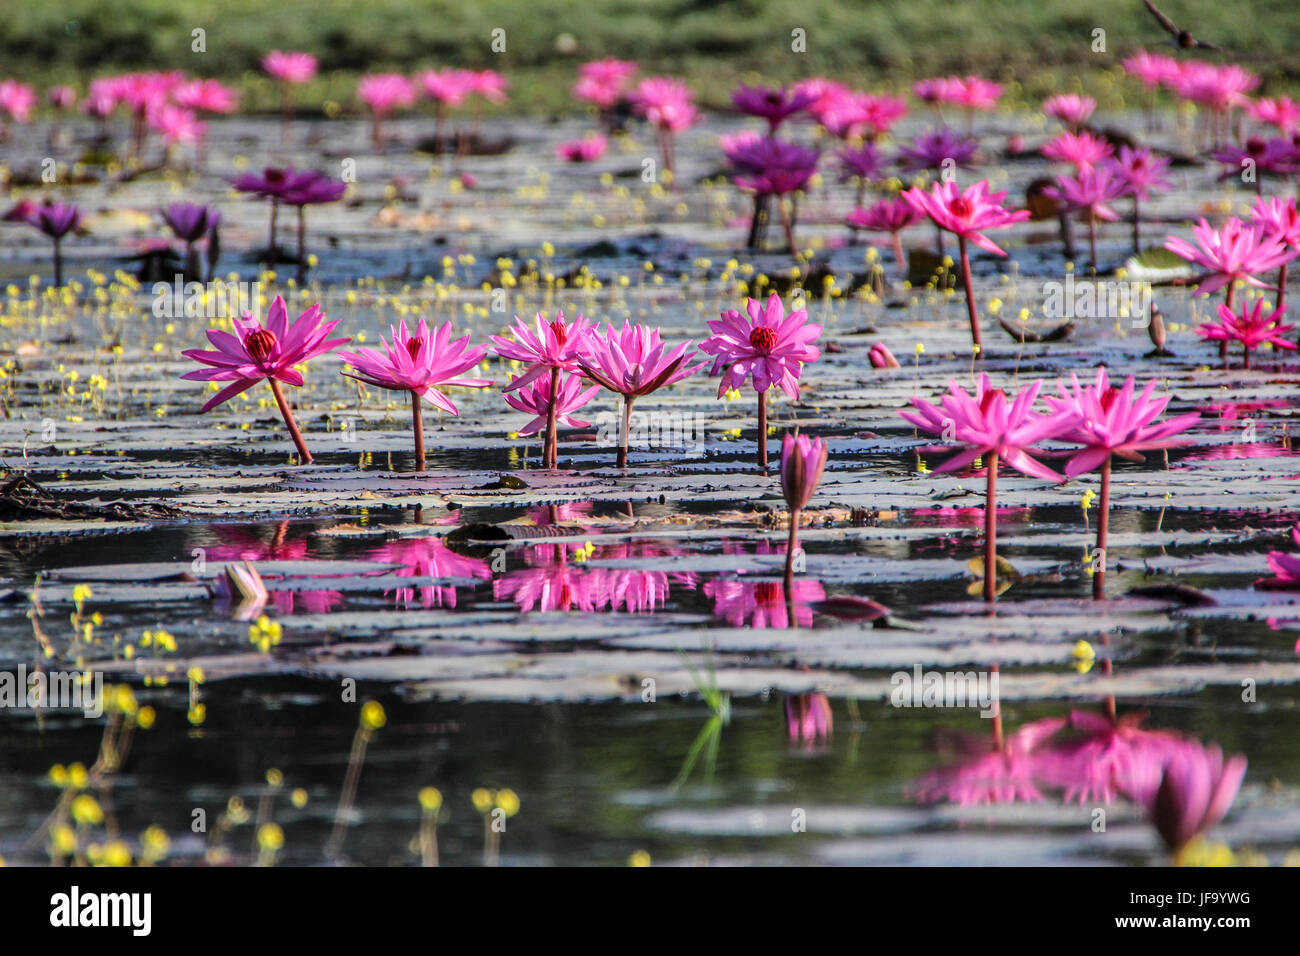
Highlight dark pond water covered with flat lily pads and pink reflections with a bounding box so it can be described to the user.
[0,106,1300,865]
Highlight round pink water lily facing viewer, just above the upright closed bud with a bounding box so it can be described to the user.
[699,293,822,468]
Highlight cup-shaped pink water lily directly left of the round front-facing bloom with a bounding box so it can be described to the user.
[577,320,705,468]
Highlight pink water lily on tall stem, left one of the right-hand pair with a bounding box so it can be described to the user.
[898,375,1074,602]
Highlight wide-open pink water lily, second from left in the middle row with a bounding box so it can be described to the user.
[339,319,491,471]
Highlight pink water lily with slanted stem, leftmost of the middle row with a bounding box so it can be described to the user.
[181,295,350,464]
